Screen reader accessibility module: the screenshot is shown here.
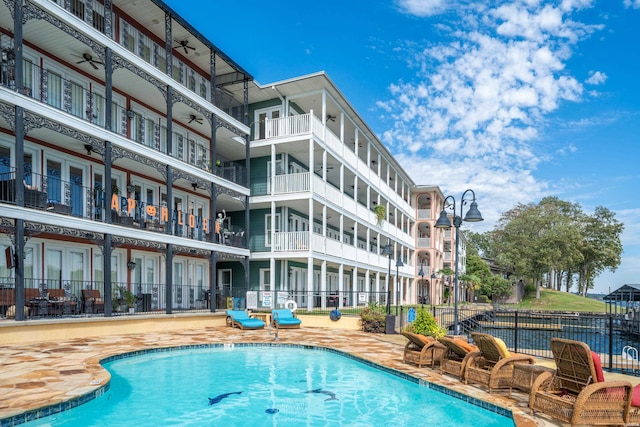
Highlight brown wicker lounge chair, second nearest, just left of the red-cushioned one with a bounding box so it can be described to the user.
[464,332,536,393]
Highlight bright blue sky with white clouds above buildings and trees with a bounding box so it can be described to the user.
[167,0,640,292]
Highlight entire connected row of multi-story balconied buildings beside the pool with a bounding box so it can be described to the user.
[0,0,460,319]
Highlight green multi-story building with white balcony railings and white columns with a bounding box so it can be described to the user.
[245,73,416,307]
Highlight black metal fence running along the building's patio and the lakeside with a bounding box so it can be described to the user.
[0,279,640,376]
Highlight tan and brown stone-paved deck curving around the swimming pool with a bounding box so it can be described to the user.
[0,327,637,427]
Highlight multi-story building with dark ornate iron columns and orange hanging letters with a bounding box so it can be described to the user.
[0,0,252,318]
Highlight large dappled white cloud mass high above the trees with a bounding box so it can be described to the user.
[378,0,604,229]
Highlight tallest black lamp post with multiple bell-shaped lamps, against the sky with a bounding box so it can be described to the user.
[435,189,484,335]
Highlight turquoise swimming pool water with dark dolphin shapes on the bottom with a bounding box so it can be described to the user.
[23,346,514,427]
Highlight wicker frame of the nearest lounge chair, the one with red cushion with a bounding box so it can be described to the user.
[529,338,631,426]
